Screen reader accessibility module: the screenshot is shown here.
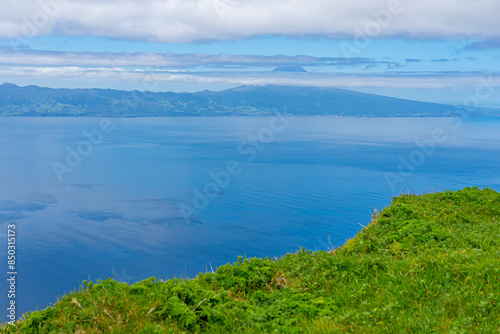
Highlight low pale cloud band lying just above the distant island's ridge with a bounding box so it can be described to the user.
[0,66,500,91]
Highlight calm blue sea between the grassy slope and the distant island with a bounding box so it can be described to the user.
[0,117,500,320]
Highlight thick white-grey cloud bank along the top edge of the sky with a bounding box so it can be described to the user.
[0,0,500,43]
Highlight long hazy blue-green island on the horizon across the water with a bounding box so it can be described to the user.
[0,83,500,117]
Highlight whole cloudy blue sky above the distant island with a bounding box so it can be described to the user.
[0,0,500,107]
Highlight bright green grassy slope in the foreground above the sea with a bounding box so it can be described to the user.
[1,188,500,333]
